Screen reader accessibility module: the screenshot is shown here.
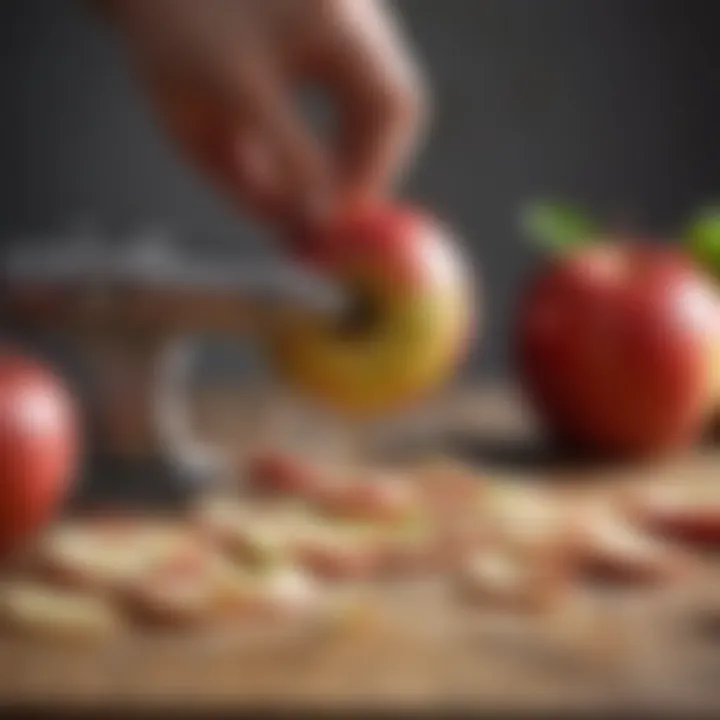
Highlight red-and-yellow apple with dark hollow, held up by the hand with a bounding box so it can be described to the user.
[270,205,477,417]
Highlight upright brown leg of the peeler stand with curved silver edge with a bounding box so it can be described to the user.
[77,336,227,505]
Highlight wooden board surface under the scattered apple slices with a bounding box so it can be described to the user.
[0,388,720,715]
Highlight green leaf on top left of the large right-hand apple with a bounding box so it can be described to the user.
[520,202,599,252]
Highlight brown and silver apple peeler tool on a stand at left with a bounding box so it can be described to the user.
[0,244,345,503]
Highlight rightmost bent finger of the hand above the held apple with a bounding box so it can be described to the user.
[325,0,428,197]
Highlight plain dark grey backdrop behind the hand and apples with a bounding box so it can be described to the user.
[0,0,720,374]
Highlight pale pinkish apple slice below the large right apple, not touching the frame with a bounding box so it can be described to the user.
[571,501,694,584]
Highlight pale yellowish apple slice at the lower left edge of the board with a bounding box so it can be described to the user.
[0,581,123,641]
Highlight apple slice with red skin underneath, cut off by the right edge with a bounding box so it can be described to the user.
[627,477,720,546]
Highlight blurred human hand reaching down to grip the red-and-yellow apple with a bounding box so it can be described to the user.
[101,0,426,231]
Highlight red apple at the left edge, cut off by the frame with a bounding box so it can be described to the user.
[0,352,80,558]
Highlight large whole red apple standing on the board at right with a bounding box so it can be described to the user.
[517,241,720,459]
